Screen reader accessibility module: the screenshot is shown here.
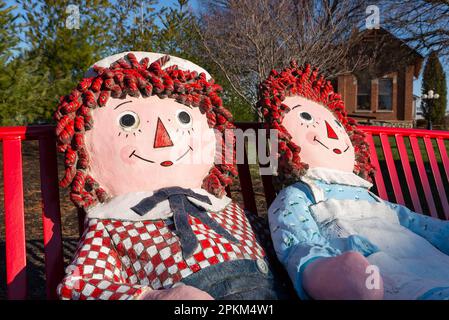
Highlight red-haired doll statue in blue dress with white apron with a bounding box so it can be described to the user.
[259,62,449,299]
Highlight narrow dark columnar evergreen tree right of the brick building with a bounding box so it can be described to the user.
[421,52,447,124]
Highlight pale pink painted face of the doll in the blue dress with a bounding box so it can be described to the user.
[282,96,355,172]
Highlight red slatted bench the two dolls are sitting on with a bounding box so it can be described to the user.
[0,123,449,299]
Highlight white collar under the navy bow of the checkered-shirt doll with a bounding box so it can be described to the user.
[87,189,232,221]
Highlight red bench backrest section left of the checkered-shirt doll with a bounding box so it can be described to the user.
[0,126,64,299]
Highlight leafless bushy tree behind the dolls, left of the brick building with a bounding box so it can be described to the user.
[197,0,371,106]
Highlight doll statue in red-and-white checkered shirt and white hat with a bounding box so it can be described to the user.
[55,52,281,300]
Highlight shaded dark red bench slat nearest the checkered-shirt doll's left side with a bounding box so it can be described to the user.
[39,137,64,299]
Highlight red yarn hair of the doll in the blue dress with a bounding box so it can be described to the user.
[258,61,374,183]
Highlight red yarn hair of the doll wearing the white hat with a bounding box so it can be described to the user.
[55,53,237,209]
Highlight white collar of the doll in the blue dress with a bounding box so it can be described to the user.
[301,168,373,189]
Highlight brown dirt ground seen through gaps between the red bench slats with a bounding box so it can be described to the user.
[0,141,266,300]
